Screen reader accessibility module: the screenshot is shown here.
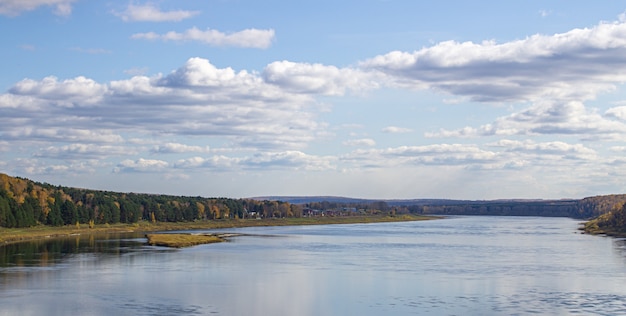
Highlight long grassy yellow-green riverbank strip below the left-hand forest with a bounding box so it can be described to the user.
[0,215,441,245]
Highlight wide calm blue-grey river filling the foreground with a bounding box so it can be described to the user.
[0,217,626,315]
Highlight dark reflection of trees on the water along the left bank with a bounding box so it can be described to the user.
[0,234,143,268]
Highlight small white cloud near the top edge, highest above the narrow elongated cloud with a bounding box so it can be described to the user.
[114,4,200,22]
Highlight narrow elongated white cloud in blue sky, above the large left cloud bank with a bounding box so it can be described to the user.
[131,27,275,49]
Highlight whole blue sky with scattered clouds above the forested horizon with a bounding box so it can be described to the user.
[0,0,626,200]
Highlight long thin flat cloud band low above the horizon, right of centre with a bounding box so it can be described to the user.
[340,139,607,171]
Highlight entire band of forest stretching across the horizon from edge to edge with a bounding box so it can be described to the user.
[0,173,626,229]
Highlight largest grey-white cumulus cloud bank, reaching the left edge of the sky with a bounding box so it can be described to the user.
[0,58,324,153]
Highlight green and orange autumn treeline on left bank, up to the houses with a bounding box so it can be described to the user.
[0,174,302,227]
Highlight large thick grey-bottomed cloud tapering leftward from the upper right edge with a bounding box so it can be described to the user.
[360,19,626,102]
